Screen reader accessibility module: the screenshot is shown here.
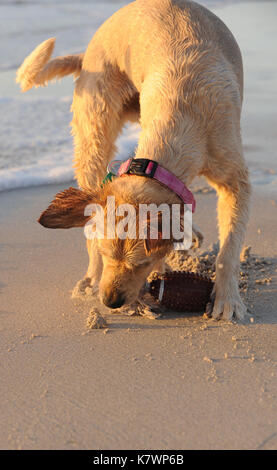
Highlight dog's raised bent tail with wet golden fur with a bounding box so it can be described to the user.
[16,38,84,91]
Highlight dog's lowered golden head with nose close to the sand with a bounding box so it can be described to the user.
[38,184,173,308]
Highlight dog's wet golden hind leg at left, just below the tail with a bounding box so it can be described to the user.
[72,60,136,189]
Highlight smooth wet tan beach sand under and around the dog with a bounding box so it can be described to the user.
[0,186,277,449]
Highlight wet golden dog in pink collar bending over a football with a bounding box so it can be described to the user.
[17,0,250,320]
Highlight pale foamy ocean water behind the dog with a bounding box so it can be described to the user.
[0,0,277,193]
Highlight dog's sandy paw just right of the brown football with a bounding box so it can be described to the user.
[209,294,247,321]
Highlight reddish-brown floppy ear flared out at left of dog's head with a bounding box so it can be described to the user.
[38,188,96,228]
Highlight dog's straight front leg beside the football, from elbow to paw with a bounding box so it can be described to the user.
[209,175,250,320]
